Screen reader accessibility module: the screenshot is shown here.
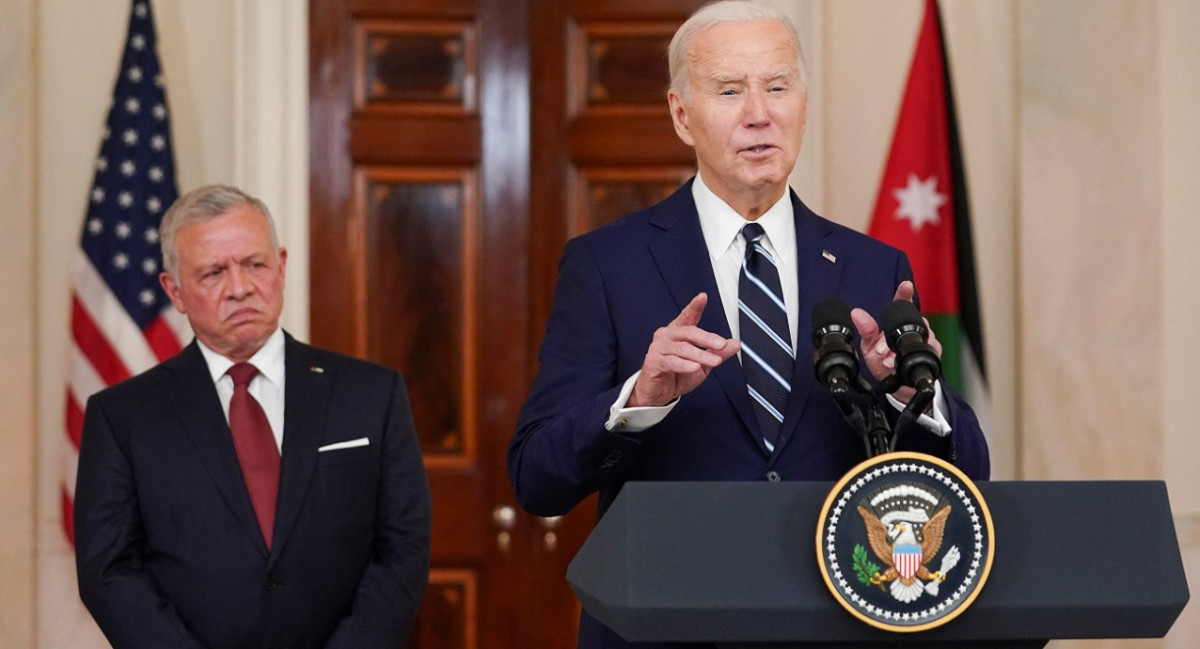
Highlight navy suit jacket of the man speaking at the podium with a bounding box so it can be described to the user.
[508,182,989,648]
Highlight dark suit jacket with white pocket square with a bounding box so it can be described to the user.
[74,336,430,649]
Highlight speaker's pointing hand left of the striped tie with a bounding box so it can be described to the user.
[625,293,742,407]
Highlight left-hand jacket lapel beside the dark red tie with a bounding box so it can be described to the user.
[163,341,266,554]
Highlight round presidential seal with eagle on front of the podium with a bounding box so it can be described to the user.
[817,452,995,632]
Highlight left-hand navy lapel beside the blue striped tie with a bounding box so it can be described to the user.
[649,182,762,445]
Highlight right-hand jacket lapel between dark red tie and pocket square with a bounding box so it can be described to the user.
[271,335,335,561]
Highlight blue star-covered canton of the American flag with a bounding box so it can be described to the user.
[80,0,179,329]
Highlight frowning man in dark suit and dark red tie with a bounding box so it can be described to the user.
[74,186,430,649]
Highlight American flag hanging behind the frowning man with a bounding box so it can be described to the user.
[62,0,191,542]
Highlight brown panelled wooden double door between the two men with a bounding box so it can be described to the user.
[310,0,700,649]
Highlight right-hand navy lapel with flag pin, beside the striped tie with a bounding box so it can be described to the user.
[773,192,844,459]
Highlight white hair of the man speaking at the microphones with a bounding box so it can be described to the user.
[667,0,809,103]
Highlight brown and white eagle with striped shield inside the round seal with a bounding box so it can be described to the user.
[858,482,961,603]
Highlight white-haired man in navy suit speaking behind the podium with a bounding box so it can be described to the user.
[508,1,989,648]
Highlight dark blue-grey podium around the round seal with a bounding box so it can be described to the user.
[566,481,1188,649]
